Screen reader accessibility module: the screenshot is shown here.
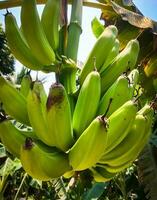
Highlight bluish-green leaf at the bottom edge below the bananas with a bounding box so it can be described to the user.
[83,183,108,200]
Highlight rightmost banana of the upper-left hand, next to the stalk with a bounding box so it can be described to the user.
[41,0,61,51]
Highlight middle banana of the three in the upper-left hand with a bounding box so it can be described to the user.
[21,0,55,65]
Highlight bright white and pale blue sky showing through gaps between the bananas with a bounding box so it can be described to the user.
[0,0,157,87]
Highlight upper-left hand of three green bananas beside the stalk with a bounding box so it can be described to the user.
[5,0,60,71]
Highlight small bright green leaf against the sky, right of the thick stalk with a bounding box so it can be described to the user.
[91,17,105,38]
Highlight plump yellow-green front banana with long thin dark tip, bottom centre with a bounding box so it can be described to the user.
[69,116,107,171]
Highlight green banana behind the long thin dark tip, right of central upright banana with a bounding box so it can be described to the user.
[97,75,133,117]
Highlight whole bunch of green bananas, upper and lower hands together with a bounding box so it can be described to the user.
[0,0,153,182]
